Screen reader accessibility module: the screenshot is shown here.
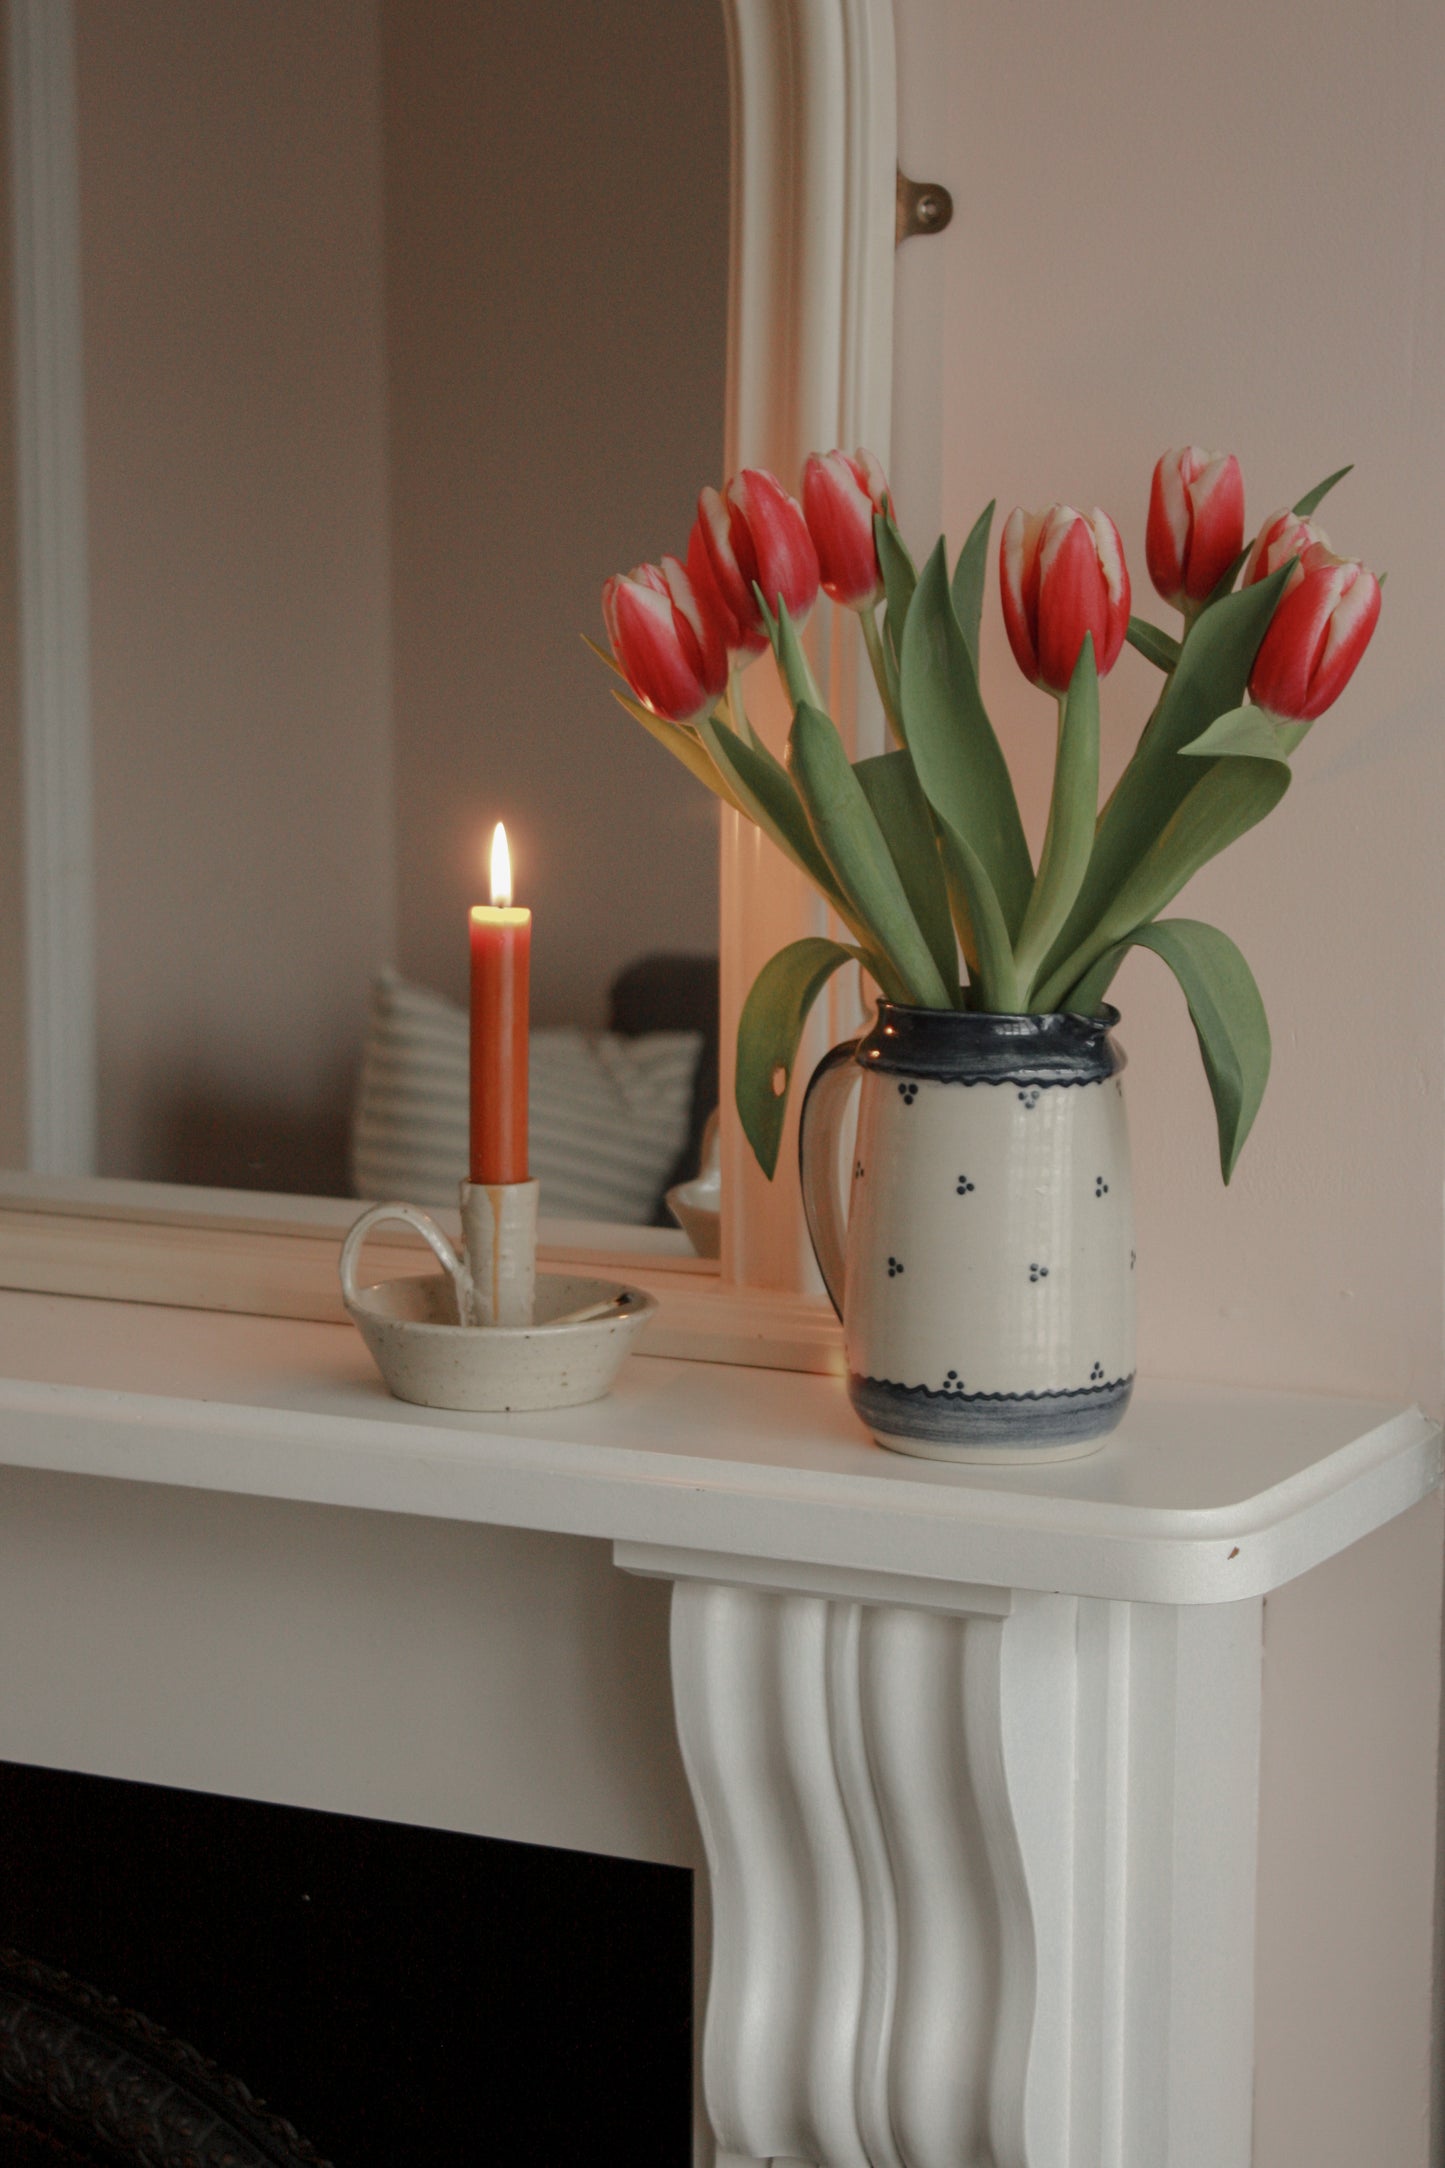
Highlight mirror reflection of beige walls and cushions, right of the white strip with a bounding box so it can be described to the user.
[18,0,728,1248]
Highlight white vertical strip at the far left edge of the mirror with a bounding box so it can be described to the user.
[6,0,95,1175]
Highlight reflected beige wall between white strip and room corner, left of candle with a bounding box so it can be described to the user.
[78,0,392,1188]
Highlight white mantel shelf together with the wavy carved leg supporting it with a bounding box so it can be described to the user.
[0,1294,1441,2168]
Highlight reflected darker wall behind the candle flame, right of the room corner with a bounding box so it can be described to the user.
[381,0,728,1023]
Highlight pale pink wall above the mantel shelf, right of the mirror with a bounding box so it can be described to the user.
[895,0,1445,1405]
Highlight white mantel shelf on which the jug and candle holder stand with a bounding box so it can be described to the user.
[0,1294,1441,1604]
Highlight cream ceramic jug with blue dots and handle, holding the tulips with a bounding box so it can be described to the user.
[799,1002,1135,1461]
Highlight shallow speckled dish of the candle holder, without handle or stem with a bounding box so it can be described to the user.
[347,1273,656,1416]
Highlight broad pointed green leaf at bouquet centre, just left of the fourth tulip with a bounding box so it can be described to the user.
[899,542,1033,939]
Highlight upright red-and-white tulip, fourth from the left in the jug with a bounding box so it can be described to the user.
[999,505,1129,694]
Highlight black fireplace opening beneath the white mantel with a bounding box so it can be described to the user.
[0,1763,693,2168]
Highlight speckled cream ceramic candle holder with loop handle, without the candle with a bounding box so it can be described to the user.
[340,1182,656,1414]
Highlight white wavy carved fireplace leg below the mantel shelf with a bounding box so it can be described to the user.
[672,1578,1263,2168]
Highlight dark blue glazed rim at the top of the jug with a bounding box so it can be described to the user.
[856,1002,1124,1084]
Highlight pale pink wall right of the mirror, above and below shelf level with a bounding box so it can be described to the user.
[895,0,1445,2168]
